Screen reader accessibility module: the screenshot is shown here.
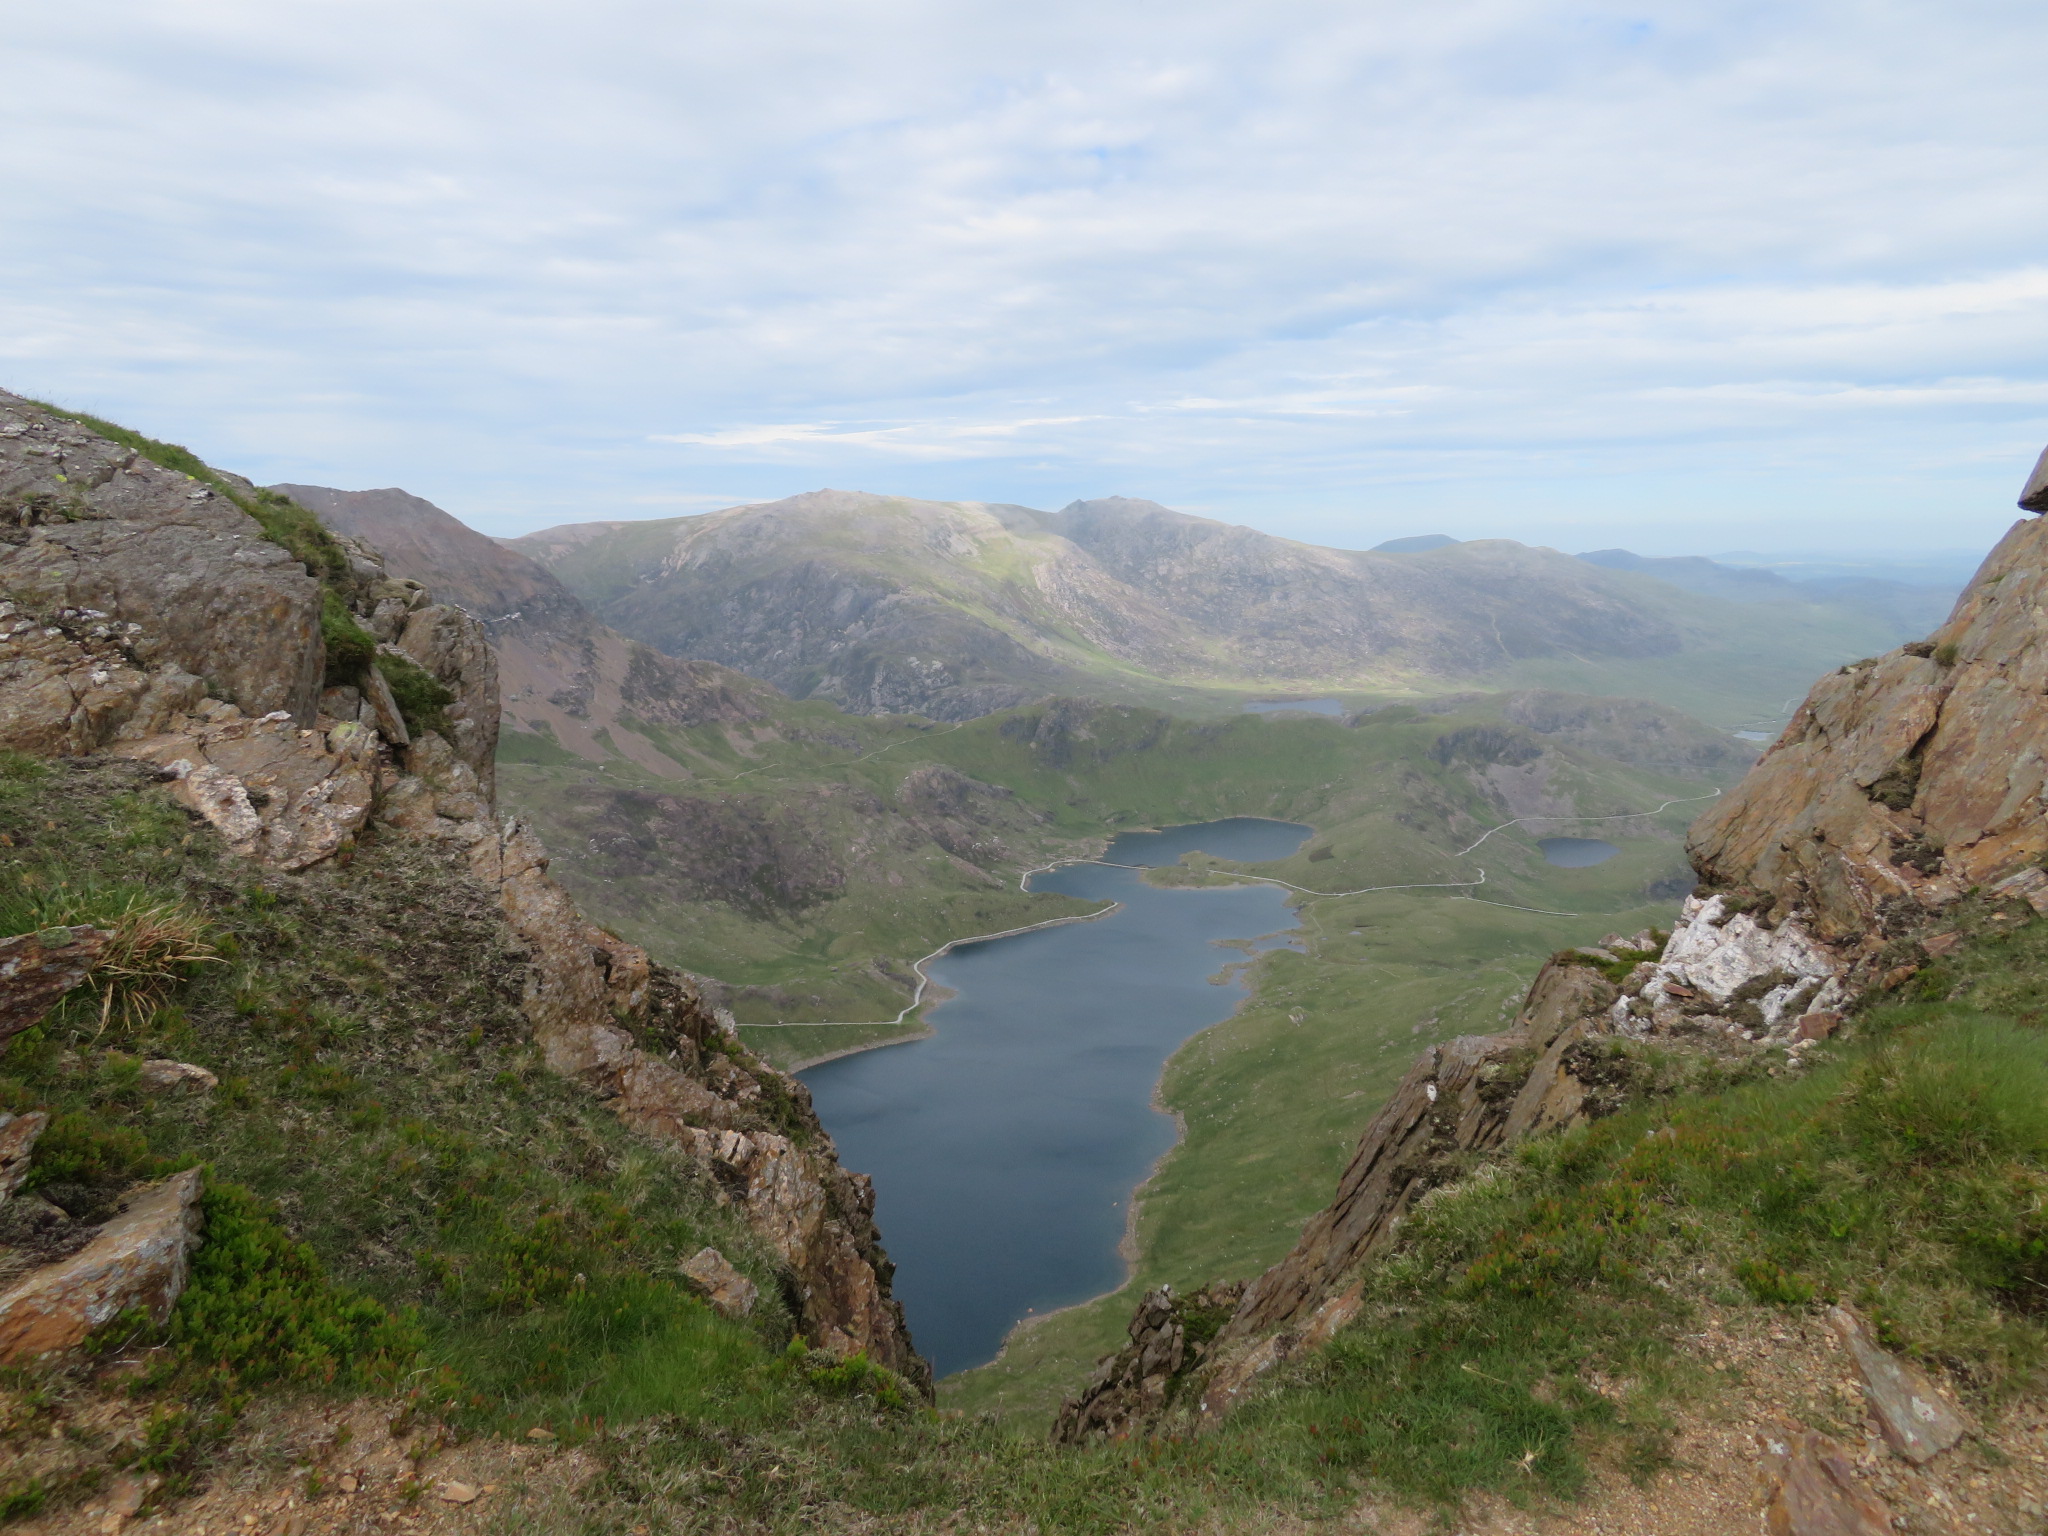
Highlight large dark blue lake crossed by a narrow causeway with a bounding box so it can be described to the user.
[803,817,1313,1376]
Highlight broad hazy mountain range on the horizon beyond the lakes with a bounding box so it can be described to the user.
[508,492,1917,725]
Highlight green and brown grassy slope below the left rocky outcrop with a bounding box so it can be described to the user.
[0,758,801,1468]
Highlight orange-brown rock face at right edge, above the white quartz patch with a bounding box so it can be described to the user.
[1690,520,2048,940]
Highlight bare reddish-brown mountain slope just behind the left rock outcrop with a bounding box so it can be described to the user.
[274,485,764,770]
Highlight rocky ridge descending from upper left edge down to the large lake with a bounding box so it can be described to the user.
[0,393,930,1391]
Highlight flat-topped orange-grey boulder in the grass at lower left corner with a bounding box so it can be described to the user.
[0,1167,201,1366]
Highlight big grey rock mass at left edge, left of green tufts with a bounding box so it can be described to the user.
[0,391,322,754]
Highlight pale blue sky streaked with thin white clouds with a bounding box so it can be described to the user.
[0,0,2048,553]
